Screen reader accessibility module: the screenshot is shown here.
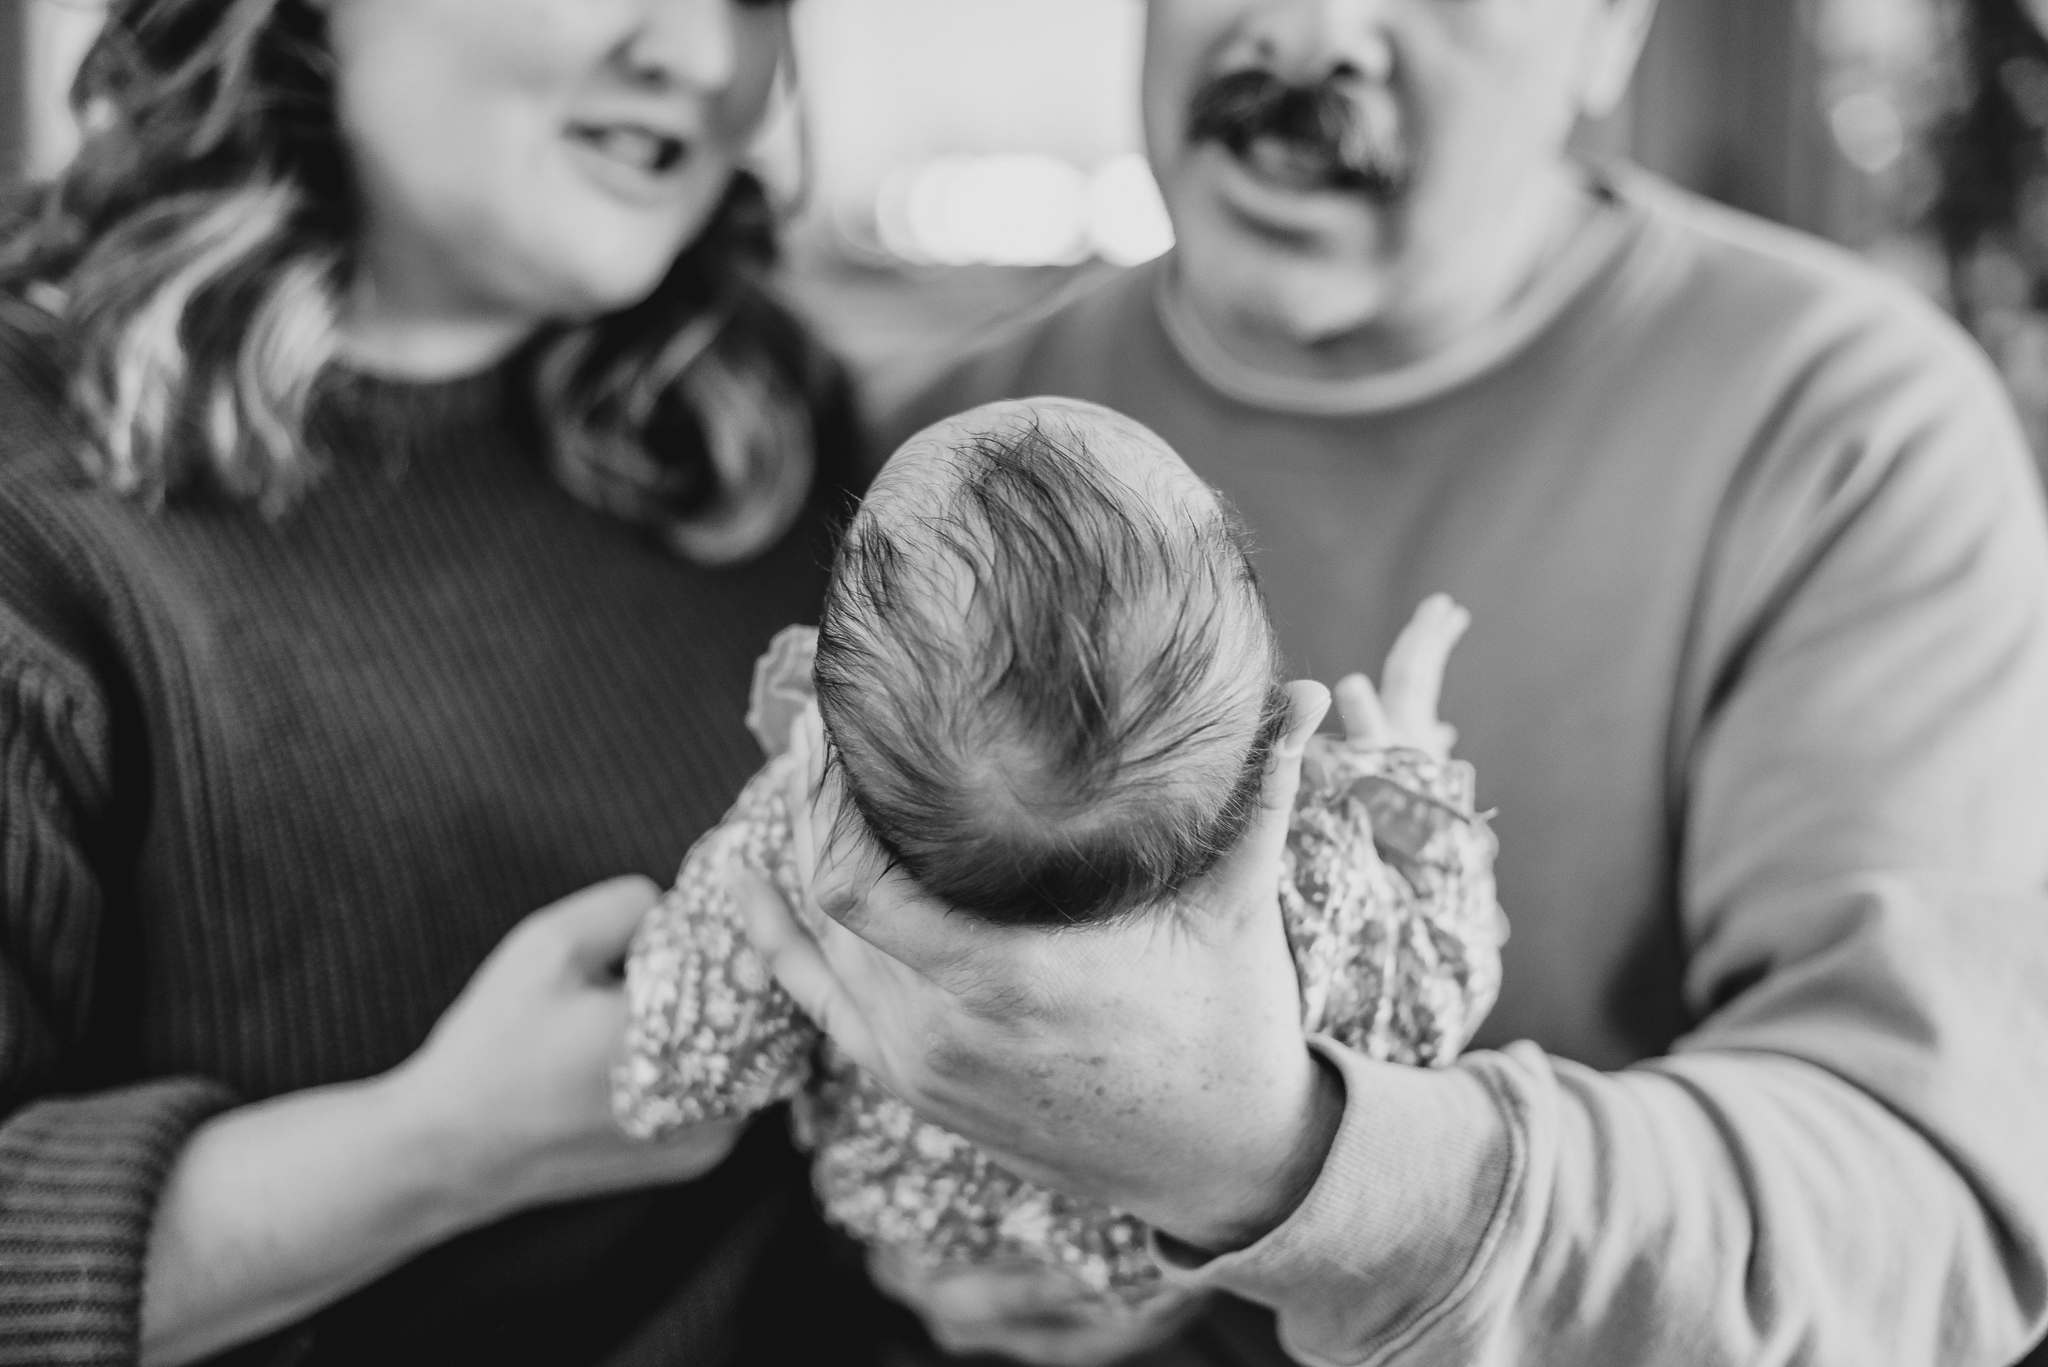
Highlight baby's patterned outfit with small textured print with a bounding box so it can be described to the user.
[612,627,1507,1308]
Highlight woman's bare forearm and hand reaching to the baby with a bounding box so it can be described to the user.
[141,879,739,1367]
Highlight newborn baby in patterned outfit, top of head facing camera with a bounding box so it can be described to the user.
[614,400,1505,1306]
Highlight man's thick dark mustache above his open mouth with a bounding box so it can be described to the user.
[1188,70,1413,199]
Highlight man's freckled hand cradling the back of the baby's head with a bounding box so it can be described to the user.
[741,685,1343,1250]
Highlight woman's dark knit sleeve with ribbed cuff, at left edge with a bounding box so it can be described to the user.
[0,603,231,1363]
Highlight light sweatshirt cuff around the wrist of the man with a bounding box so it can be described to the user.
[1153,1037,1520,1365]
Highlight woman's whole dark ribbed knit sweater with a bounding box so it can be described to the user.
[0,309,872,1363]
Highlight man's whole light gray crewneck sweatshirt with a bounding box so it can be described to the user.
[891,174,2048,1367]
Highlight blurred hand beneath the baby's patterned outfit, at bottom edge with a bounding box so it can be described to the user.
[868,1252,1204,1367]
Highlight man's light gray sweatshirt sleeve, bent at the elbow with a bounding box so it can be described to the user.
[1163,313,2048,1367]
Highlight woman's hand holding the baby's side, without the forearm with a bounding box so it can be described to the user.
[389,877,741,1217]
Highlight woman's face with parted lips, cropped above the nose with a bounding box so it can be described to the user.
[324,0,786,322]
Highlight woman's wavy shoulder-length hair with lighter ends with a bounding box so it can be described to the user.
[0,0,829,564]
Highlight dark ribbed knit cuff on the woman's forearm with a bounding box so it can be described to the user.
[0,1080,236,1365]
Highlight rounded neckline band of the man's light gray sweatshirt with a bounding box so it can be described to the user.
[1153,166,1640,418]
